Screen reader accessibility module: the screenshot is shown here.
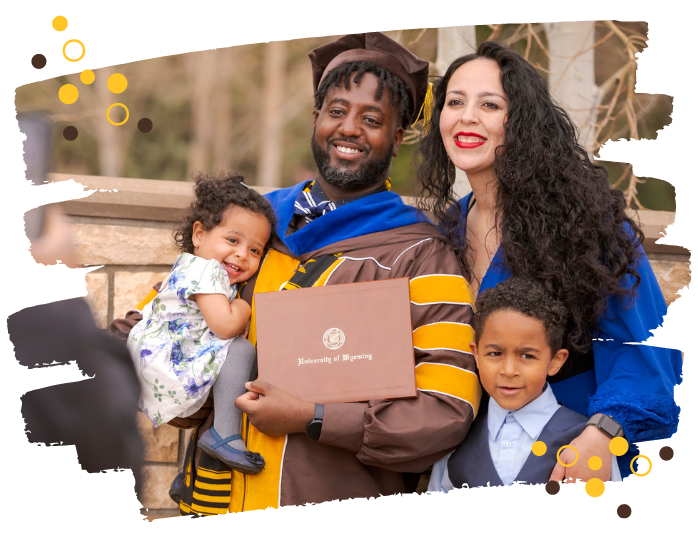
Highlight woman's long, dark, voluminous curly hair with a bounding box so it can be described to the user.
[417,41,644,353]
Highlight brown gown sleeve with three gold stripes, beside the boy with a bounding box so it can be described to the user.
[320,237,481,472]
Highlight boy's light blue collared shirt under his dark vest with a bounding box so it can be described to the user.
[427,384,623,493]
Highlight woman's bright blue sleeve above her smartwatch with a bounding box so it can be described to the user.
[588,248,683,443]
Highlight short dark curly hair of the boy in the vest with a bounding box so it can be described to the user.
[471,278,570,355]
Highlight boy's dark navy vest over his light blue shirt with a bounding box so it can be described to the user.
[448,401,588,488]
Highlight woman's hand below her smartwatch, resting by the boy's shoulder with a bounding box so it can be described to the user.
[550,425,613,484]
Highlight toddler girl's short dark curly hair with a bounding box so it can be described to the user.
[174,172,276,254]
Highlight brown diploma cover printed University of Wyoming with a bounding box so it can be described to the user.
[254,277,417,404]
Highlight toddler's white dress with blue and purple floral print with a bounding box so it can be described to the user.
[128,253,237,427]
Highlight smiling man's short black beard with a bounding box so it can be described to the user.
[310,129,394,192]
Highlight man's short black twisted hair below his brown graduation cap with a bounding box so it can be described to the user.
[315,60,413,130]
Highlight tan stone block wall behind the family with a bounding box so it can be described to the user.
[50,174,691,518]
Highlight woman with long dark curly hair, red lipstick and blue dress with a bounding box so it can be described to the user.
[418,42,682,481]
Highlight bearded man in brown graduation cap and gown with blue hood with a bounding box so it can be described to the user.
[113,32,481,516]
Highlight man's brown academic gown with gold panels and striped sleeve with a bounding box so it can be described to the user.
[113,223,481,515]
